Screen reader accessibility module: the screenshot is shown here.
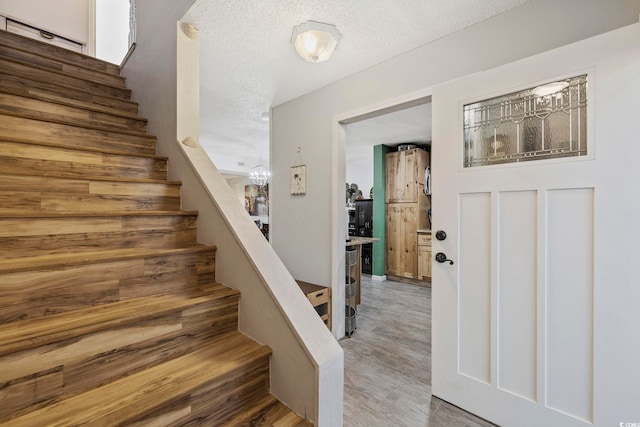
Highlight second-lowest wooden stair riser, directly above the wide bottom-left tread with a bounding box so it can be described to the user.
[0,302,238,422]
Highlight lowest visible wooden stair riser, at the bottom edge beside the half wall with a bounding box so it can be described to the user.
[132,360,269,427]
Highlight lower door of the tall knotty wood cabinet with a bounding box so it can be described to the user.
[386,203,418,279]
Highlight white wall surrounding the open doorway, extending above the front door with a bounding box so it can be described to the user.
[270,0,640,342]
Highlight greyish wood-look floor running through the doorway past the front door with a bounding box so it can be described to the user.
[340,276,493,427]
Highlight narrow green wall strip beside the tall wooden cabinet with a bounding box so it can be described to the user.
[372,145,391,276]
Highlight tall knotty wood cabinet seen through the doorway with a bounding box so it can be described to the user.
[385,148,430,279]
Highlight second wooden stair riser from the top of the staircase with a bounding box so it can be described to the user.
[0,44,126,88]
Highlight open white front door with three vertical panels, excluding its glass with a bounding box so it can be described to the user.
[432,24,640,427]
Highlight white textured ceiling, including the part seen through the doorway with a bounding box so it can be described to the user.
[184,0,528,173]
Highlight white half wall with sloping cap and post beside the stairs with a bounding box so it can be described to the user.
[175,22,344,427]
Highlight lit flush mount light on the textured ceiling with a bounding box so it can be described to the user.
[291,21,342,63]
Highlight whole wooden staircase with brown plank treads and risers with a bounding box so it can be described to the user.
[0,31,310,426]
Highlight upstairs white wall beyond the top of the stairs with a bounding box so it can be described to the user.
[0,0,94,44]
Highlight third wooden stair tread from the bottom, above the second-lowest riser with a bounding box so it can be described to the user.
[0,285,239,356]
